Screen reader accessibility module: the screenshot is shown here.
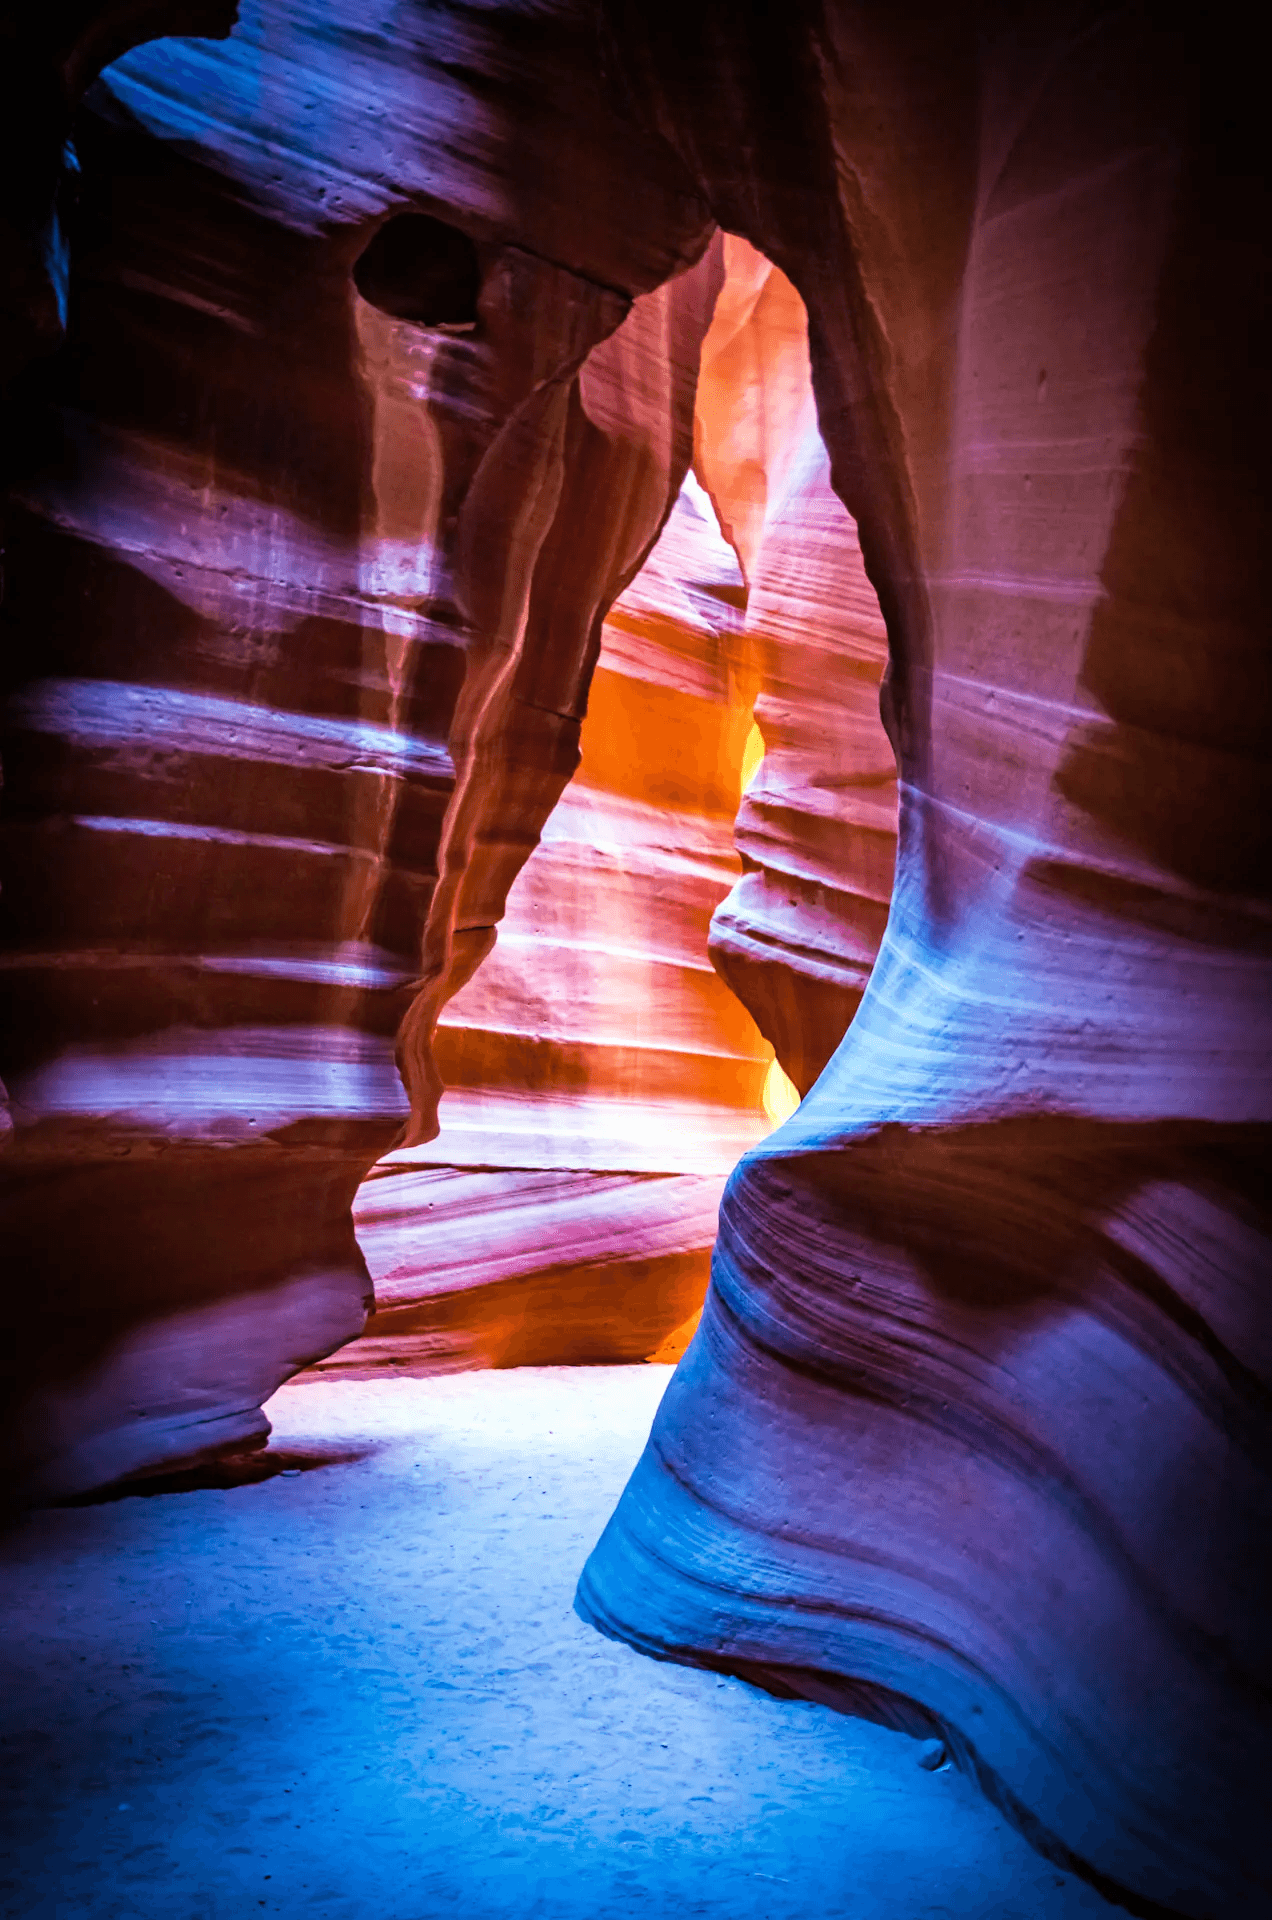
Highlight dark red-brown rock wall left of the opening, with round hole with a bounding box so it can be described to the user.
[0,0,719,1494]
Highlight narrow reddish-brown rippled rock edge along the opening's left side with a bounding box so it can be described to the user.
[400,242,736,1144]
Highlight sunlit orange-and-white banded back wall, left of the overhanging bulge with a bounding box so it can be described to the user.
[321,474,772,1375]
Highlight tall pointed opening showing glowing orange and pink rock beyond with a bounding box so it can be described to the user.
[334,238,895,1377]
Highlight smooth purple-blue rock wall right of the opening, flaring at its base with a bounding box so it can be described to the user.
[578,0,1272,1920]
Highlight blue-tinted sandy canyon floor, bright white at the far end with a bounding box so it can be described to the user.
[0,1367,1113,1920]
